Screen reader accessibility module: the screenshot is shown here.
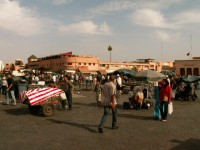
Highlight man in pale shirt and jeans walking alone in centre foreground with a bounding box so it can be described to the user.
[98,75,118,133]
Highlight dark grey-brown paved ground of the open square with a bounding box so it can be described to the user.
[0,91,200,150]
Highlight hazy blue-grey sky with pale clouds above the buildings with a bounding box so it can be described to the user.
[0,0,200,63]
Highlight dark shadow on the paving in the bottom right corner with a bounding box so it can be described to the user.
[170,138,200,150]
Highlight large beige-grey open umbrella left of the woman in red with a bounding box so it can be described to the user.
[135,70,165,81]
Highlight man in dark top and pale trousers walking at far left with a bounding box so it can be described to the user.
[6,73,16,106]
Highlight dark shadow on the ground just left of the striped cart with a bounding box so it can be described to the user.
[3,106,30,116]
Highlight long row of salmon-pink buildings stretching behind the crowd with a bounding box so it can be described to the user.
[27,52,173,73]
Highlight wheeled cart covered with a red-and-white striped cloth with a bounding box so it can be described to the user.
[20,87,66,117]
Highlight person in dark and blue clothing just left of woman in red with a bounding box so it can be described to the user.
[153,82,161,120]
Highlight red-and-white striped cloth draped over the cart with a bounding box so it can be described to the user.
[20,87,64,105]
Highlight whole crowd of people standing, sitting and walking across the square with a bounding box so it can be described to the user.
[0,70,199,133]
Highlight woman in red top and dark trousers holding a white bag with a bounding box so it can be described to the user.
[160,79,172,121]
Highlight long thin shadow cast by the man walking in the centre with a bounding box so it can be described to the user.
[47,119,98,133]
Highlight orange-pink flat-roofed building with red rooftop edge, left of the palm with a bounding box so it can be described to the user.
[27,52,99,71]
